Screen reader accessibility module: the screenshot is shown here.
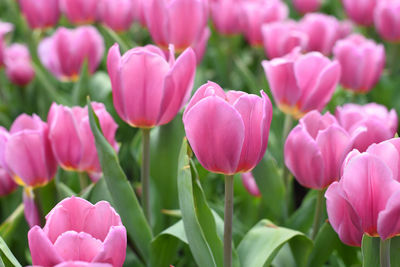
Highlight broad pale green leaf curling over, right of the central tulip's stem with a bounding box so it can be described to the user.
[238,220,312,267]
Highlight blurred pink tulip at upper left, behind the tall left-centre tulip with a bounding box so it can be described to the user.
[38,26,104,81]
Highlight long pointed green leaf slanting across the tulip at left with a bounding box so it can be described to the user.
[88,100,152,262]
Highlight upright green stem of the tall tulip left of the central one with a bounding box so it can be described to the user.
[141,128,151,224]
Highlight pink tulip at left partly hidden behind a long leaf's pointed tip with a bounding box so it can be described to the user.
[47,102,118,182]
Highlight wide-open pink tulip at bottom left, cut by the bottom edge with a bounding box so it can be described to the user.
[28,197,127,267]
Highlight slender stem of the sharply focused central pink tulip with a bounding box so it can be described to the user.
[224,175,233,267]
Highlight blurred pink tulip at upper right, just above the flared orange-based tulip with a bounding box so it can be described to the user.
[300,13,342,55]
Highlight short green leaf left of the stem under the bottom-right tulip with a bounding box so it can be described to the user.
[361,235,380,267]
